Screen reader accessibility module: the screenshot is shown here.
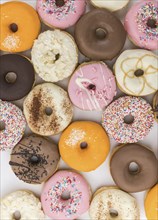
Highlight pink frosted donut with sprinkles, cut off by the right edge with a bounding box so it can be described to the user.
[125,0,158,50]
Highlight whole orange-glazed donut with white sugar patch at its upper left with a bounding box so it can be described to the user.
[59,121,110,172]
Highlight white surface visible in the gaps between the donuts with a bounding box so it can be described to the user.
[0,1,158,220]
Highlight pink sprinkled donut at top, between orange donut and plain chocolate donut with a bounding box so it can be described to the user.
[37,0,86,29]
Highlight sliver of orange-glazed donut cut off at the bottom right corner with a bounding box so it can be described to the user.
[145,184,158,220]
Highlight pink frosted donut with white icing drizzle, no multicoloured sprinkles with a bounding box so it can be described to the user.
[68,62,116,111]
